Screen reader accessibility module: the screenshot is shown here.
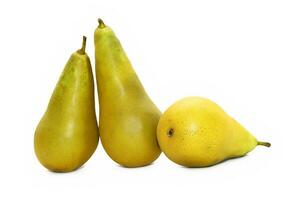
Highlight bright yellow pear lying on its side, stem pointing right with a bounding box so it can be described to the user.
[157,97,270,167]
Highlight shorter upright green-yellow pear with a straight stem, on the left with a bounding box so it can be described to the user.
[34,37,98,172]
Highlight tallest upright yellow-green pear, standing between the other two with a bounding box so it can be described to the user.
[94,19,161,167]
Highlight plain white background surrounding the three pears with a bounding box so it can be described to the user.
[0,0,283,200]
